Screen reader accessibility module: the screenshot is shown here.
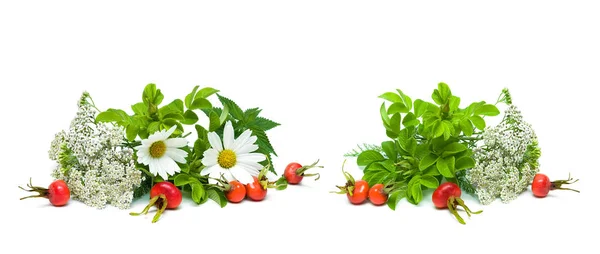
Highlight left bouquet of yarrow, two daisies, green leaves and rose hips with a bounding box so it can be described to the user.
[41,84,283,221]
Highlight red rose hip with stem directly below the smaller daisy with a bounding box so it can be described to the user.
[129,182,182,223]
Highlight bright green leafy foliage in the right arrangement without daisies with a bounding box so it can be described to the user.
[355,83,500,209]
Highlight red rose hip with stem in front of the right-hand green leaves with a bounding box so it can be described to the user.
[431,182,483,224]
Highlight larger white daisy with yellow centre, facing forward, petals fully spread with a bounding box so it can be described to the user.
[200,121,266,184]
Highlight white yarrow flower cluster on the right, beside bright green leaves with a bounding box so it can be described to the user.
[466,105,539,205]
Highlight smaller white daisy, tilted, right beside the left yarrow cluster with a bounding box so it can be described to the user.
[135,125,187,180]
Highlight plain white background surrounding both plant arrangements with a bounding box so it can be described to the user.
[0,0,600,253]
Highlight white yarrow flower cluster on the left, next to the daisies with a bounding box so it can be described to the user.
[49,93,143,209]
